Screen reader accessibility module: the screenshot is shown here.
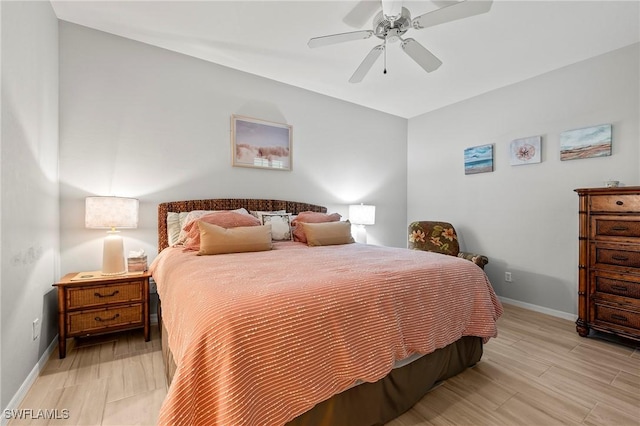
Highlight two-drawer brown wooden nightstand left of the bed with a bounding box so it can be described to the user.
[54,272,151,358]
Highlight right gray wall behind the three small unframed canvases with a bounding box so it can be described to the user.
[407,44,640,316]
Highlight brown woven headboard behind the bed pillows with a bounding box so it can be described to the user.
[158,198,327,253]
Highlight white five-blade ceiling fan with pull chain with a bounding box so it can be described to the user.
[308,0,493,83]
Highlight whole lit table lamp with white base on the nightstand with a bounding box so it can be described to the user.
[84,197,138,275]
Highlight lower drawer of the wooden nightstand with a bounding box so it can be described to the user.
[67,304,144,336]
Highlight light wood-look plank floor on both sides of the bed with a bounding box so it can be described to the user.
[9,305,640,426]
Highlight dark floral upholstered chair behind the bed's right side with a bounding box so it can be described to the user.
[409,221,489,269]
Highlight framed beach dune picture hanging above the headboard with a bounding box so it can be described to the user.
[231,115,293,170]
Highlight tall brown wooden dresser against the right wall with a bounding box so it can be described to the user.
[575,186,640,340]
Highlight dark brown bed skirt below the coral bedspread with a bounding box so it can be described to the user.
[158,315,482,426]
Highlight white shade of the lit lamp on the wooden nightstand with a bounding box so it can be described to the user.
[84,197,138,229]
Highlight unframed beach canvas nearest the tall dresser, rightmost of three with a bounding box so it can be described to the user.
[560,124,611,161]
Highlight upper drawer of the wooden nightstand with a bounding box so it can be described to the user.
[67,281,144,309]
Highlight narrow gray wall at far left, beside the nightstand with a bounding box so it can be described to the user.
[0,2,59,408]
